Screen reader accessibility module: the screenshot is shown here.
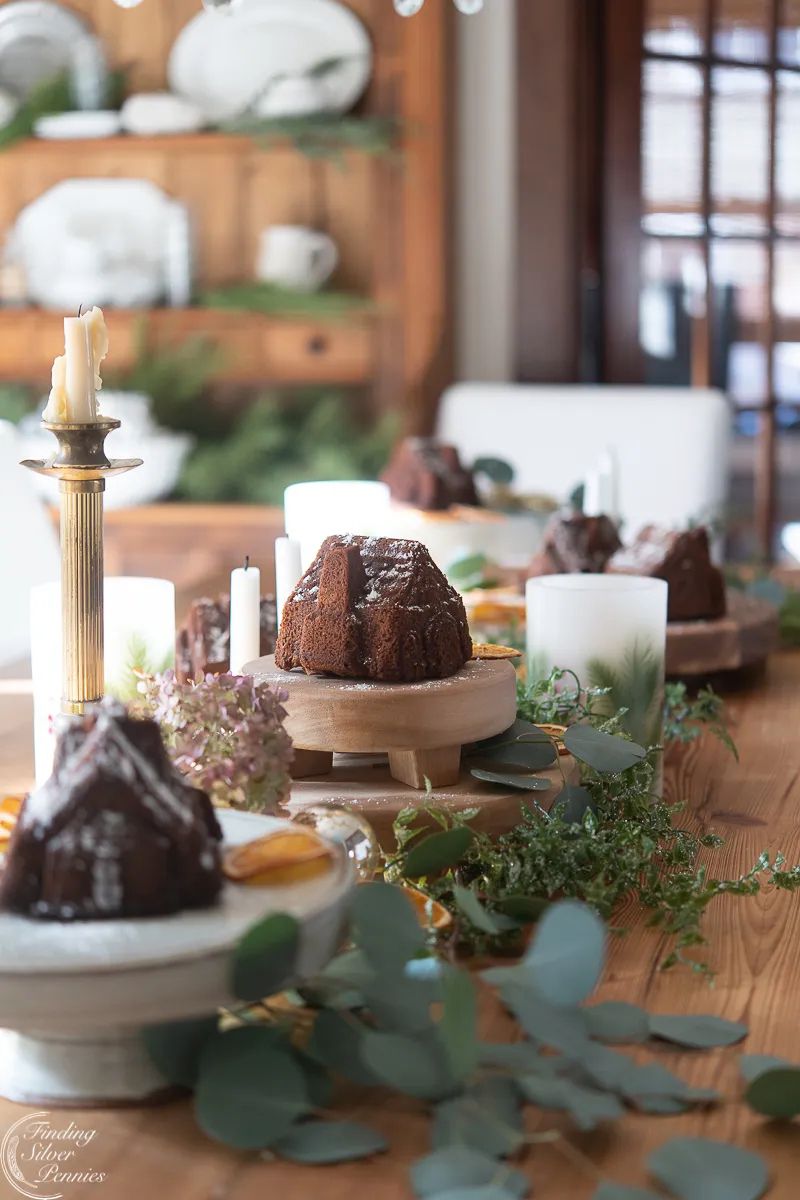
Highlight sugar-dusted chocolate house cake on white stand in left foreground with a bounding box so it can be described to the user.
[0,702,223,920]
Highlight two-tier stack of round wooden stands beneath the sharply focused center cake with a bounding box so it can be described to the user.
[245,655,537,846]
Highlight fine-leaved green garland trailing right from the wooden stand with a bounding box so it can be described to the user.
[387,671,800,973]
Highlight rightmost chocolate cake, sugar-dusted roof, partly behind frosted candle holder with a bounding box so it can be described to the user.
[607,526,727,620]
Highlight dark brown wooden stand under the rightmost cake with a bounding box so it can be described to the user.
[667,588,778,678]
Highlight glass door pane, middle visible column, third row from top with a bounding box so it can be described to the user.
[710,241,768,407]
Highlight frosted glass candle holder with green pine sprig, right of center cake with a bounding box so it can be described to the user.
[525,575,667,746]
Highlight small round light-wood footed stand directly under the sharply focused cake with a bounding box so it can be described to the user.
[245,655,517,788]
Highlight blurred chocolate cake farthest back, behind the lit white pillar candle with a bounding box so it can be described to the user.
[380,438,481,512]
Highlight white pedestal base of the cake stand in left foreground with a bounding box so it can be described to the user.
[0,1030,174,1108]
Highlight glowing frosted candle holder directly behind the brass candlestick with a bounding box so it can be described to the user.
[30,576,175,785]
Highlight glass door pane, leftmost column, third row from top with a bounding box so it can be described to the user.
[639,238,705,385]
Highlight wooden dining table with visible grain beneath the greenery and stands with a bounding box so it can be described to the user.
[0,653,800,1200]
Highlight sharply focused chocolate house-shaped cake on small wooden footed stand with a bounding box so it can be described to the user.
[275,536,473,683]
